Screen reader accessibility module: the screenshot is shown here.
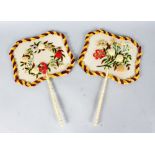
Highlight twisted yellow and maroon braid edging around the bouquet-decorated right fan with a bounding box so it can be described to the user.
[78,29,142,84]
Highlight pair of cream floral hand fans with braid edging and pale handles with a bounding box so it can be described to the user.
[9,30,142,127]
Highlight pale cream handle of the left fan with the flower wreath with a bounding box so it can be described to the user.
[46,74,64,127]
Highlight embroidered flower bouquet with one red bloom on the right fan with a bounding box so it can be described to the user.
[93,40,132,72]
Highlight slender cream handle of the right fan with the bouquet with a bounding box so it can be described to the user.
[94,70,109,126]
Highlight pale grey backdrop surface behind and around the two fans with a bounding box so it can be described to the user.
[0,21,155,133]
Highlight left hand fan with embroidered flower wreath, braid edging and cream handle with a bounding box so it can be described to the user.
[9,31,74,126]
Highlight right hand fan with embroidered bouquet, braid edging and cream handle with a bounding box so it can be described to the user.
[78,30,142,126]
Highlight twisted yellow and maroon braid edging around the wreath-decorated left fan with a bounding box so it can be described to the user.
[9,31,75,87]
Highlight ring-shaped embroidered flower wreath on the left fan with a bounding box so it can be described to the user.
[20,41,65,78]
